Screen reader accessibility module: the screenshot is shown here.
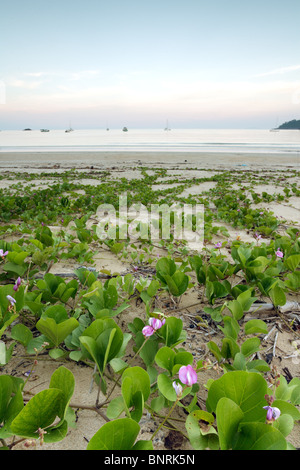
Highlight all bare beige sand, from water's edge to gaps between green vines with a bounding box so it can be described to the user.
[0,152,300,450]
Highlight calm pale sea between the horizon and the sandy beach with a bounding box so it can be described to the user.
[0,128,300,156]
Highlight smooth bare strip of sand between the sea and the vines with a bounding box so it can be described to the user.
[0,151,300,171]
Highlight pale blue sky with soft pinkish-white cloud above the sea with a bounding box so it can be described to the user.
[0,0,300,130]
